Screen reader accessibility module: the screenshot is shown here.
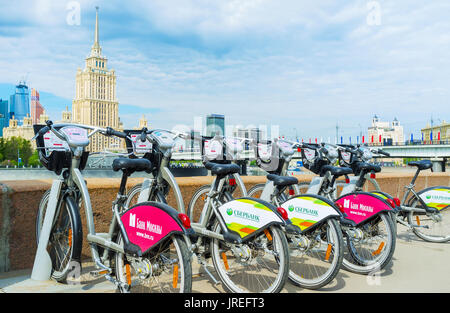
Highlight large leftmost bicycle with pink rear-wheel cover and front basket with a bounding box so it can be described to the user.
[33,121,193,292]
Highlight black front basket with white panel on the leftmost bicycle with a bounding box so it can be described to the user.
[33,125,89,175]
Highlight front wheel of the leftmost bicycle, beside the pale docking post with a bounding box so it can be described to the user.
[36,190,83,282]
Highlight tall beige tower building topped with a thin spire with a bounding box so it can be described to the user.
[72,7,121,152]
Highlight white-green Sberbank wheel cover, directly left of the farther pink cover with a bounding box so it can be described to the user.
[281,194,341,233]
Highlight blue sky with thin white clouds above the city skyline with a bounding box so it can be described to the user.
[0,0,450,141]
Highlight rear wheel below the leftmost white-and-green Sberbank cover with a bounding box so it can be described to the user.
[210,222,289,293]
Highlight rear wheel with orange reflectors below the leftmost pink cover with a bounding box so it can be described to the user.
[115,235,192,293]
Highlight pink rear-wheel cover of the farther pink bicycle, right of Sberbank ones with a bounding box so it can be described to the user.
[336,192,393,226]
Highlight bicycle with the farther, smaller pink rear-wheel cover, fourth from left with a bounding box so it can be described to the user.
[264,141,396,274]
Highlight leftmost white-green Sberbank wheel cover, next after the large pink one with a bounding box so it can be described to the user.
[217,198,285,242]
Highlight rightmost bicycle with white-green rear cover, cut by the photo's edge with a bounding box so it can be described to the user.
[340,145,450,243]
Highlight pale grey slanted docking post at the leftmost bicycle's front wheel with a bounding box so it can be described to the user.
[31,180,63,281]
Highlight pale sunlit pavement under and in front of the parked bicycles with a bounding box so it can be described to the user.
[0,225,450,293]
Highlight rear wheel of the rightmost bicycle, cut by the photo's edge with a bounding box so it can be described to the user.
[407,200,450,243]
